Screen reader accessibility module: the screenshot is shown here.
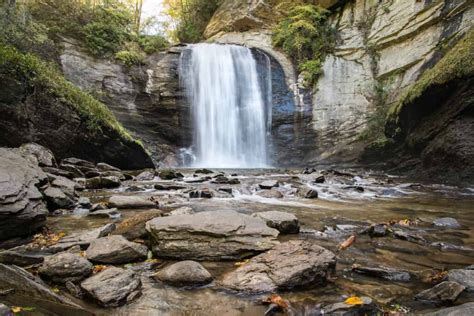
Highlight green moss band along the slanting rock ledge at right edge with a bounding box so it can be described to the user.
[388,28,474,119]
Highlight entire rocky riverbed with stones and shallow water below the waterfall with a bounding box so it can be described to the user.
[0,145,474,315]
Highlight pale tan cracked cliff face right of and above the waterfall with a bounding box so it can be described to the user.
[206,0,474,173]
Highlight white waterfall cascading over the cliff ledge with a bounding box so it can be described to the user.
[180,44,271,168]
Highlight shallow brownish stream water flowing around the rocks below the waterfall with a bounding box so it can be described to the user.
[41,169,474,316]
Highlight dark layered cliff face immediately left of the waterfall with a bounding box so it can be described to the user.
[60,40,191,166]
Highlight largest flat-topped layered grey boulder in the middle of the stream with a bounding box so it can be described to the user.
[146,211,278,260]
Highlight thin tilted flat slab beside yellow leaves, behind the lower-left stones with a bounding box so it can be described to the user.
[48,224,115,252]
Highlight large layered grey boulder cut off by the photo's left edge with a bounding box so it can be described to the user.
[0,148,48,240]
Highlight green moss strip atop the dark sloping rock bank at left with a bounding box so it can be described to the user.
[0,44,143,147]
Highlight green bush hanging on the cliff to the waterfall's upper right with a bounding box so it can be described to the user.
[273,4,334,84]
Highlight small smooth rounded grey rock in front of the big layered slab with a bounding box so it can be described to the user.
[155,260,212,286]
